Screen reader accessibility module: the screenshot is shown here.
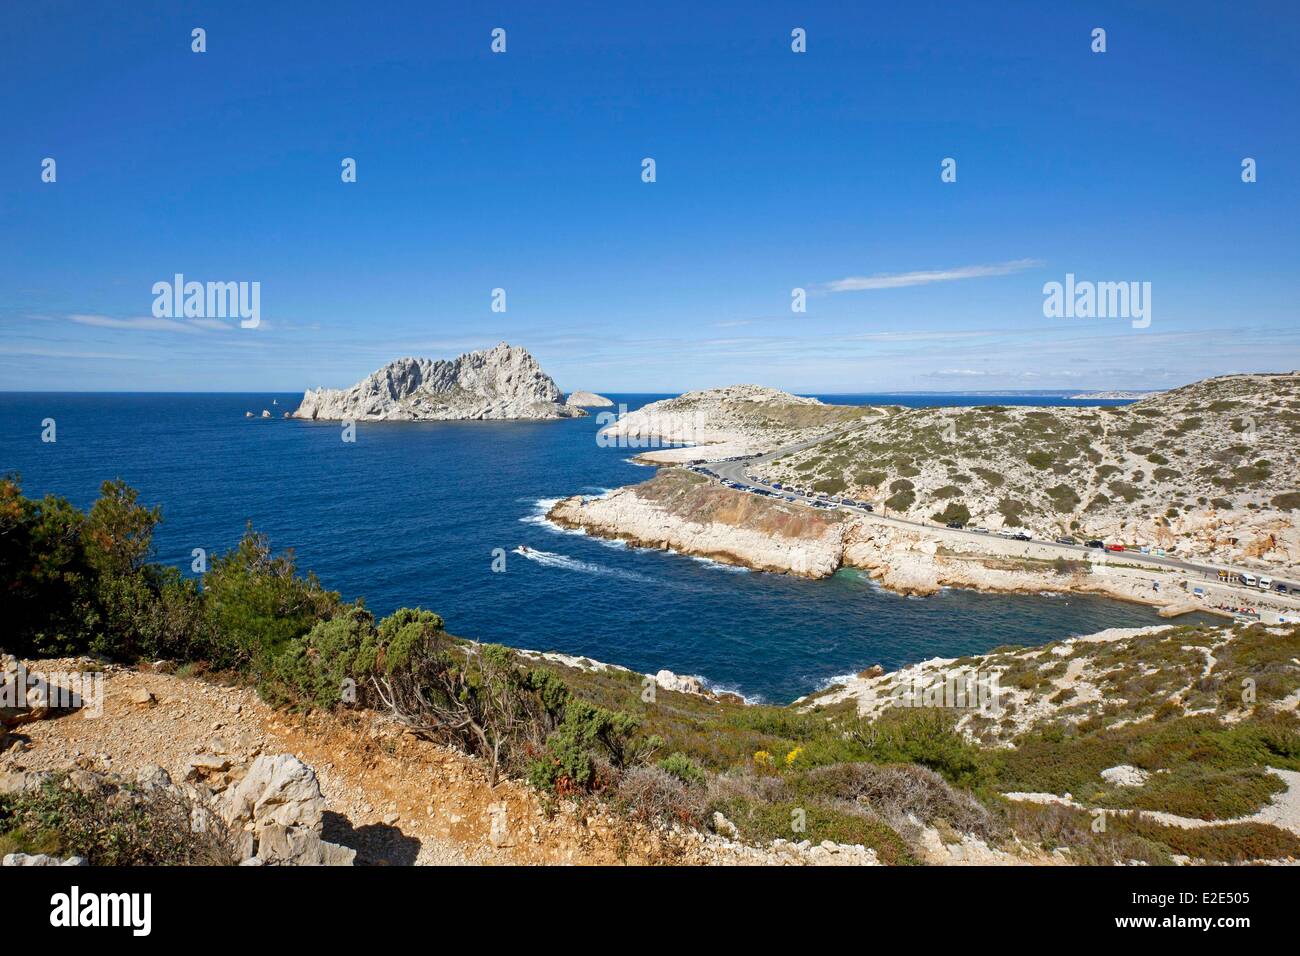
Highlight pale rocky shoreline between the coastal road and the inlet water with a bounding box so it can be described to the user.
[546,471,1300,618]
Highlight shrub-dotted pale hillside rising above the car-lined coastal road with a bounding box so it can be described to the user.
[761,372,1300,568]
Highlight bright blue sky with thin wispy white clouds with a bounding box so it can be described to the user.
[0,0,1300,393]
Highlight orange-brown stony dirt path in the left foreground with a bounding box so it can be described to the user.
[0,661,702,865]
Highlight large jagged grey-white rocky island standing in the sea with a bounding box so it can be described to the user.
[293,342,586,421]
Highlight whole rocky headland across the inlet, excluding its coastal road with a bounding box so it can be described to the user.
[549,373,1300,615]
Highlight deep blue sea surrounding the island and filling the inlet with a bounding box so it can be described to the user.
[0,393,1201,702]
